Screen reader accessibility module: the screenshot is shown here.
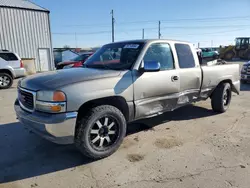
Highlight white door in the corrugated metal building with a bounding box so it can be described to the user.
[38,48,50,71]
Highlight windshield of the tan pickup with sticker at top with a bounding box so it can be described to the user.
[84,42,144,70]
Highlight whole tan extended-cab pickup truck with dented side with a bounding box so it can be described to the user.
[15,40,240,159]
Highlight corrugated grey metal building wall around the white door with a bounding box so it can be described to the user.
[0,7,54,71]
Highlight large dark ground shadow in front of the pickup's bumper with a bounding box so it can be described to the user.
[0,123,92,184]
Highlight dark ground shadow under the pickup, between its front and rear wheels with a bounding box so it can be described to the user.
[127,105,217,135]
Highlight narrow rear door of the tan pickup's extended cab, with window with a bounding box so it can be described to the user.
[175,43,202,106]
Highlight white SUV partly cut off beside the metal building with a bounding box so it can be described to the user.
[0,50,26,89]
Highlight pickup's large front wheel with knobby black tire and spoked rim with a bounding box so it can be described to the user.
[75,105,127,160]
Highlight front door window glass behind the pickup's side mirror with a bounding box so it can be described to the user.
[143,43,174,70]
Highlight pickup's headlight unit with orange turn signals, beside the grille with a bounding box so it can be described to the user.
[36,91,66,113]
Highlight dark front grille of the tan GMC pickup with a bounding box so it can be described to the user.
[18,89,34,110]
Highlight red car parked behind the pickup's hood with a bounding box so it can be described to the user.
[56,52,94,70]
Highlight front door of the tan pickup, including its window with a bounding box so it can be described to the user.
[133,43,180,119]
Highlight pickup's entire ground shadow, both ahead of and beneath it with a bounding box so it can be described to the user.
[0,106,215,183]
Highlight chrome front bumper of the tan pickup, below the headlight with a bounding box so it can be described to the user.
[14,100,77,144]
